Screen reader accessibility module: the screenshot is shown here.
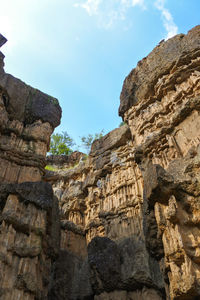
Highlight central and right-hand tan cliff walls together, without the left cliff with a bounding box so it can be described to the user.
[45,26,200,300]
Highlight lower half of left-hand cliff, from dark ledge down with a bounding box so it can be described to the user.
[0,182,59,300]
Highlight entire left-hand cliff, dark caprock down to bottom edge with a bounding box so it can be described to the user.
[0,41,61,300]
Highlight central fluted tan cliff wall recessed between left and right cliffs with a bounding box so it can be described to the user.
[45,125,165,300]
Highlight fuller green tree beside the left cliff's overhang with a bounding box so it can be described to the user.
[49,131,75,155]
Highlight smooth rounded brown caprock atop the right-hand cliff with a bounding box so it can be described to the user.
[119,25,200,118]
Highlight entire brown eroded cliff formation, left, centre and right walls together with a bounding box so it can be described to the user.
[0,26,200,300]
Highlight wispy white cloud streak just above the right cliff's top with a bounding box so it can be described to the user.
[154,0,178,39]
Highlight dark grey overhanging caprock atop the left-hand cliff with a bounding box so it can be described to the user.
[0,34,62,129]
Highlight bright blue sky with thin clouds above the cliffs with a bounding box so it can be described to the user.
[0,0,200,150]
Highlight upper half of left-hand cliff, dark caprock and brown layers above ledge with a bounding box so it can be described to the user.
[0,48,61,183]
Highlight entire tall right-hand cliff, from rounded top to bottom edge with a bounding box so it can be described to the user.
[119,26,200,299]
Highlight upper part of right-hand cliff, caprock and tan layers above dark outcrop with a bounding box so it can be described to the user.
[121,26,200,167]
